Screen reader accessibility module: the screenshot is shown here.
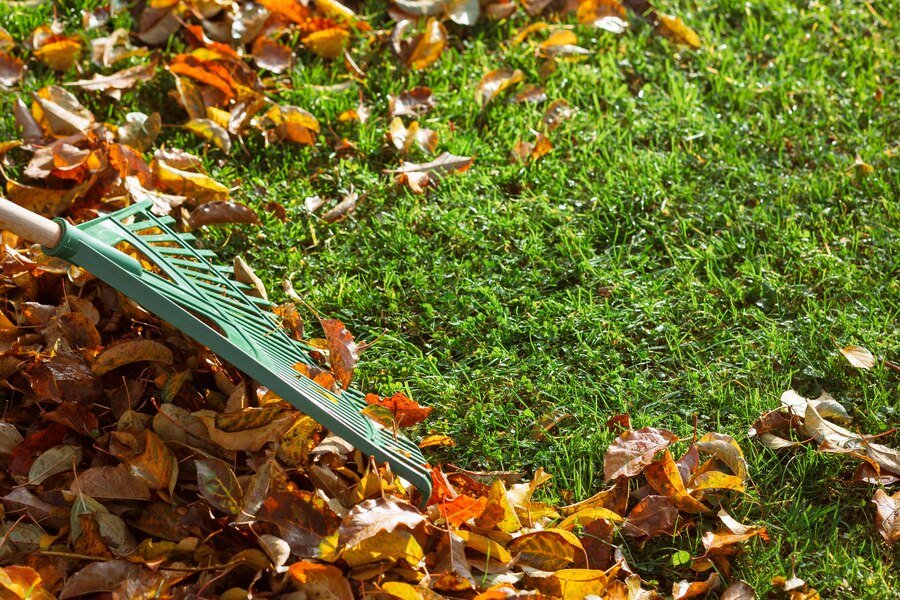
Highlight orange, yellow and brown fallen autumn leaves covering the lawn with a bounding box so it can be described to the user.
[0,0,884,599]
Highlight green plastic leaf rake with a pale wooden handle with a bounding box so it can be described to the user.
[0,198,432,503]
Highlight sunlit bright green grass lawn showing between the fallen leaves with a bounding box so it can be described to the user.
[0,0,900,598]
